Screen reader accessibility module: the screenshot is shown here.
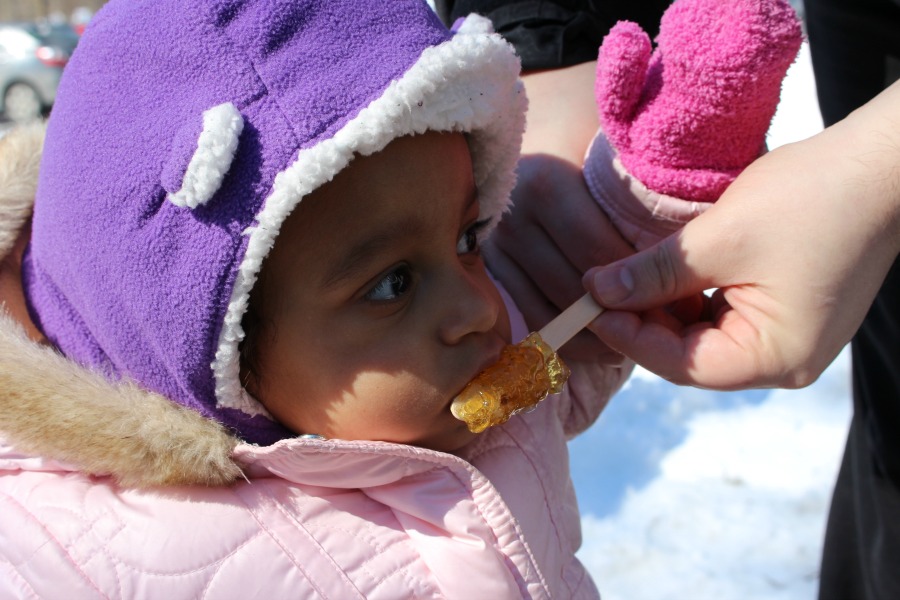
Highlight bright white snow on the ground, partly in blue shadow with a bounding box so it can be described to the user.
[570,45,851,600]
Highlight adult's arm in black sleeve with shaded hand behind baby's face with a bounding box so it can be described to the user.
[450,0,668,364]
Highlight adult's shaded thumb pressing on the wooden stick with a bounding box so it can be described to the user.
[583,230,717,311]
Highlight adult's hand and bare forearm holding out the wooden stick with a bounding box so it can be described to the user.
[584,78,900,389]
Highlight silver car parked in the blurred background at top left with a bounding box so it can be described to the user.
[0,22,78,122]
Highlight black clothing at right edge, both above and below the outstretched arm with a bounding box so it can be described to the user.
[805,0,900,600]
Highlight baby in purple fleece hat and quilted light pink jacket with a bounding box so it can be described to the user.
[0,0,627,598]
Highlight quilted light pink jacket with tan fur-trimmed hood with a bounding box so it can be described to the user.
[0,124,627,600]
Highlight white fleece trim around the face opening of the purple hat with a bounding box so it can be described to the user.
[212,15,527,418]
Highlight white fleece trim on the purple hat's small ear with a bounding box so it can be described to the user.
[168,102,244,209]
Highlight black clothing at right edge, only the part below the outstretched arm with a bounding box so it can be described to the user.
[819,260,900,600]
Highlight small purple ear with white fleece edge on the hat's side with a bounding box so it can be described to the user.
[162,102,244,209]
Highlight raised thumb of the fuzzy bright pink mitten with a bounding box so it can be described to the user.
[594,21,652,155]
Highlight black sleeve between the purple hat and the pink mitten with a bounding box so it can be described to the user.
[435,0,669,71]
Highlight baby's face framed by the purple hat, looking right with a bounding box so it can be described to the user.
[248,133,510,452]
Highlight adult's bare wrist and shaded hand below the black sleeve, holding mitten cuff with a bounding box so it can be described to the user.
[484,63,633,364]
